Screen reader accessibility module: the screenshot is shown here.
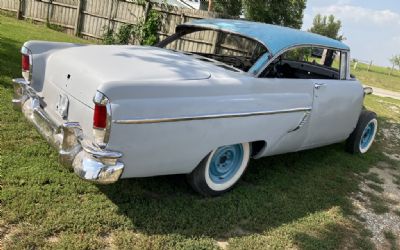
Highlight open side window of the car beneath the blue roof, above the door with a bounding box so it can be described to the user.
[260,47,347,80]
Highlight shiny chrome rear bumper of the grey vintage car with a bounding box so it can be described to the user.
[12,79,124,184]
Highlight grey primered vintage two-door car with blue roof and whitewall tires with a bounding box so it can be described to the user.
[13,19,378,196]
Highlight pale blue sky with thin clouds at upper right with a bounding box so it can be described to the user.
[303,0,400,66]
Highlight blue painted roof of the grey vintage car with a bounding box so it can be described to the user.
[177,19,350,55]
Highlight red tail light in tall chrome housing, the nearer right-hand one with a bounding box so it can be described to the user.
[93,92,111,148]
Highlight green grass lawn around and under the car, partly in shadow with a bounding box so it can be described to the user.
[0,15,400,249]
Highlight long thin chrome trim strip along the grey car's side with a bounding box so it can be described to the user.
[113,107,312,124]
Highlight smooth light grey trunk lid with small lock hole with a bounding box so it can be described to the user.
[45,45,211,107]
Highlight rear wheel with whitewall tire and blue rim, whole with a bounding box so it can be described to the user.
[188,143,251,196]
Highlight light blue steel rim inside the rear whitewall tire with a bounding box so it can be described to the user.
[209,144,244,184]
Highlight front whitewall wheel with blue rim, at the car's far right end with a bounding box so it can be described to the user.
[346,110,378,154]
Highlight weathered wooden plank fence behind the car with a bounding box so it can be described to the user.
[0,0,230,39]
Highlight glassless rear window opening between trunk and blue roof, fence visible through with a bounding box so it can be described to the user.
[159,30,267,72]
